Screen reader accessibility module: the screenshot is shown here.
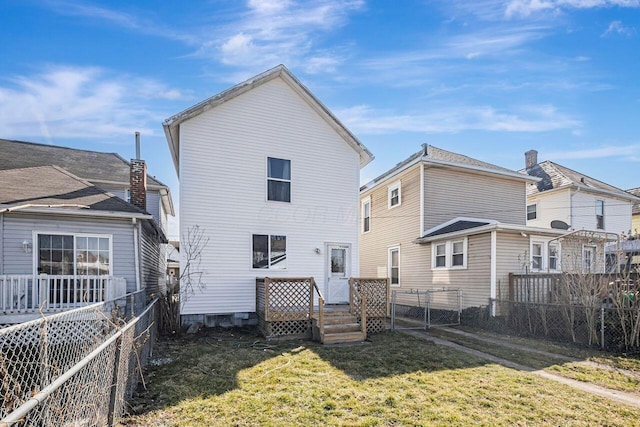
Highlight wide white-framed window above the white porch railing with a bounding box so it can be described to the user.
[37,234,111,276]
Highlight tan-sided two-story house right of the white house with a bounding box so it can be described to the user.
[360,145,604,314]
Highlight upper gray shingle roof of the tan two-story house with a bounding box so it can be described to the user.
[360,144,537,191]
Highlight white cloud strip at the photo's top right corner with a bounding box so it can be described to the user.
[505,0,640,18]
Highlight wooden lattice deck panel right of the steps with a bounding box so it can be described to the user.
[349,277,390,334]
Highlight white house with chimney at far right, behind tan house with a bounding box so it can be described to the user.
[521,150,640,238]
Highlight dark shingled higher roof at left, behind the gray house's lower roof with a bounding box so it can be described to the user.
[0,139,174,215]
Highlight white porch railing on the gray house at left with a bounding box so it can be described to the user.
[0,274,127,315]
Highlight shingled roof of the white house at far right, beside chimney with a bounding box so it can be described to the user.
[521,160,640,202]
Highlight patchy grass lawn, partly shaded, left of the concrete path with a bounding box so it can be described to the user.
[123,331,637,426]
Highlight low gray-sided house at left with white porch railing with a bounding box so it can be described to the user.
[0,166,166,324]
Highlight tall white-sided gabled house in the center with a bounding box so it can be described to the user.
[164,65,372,324]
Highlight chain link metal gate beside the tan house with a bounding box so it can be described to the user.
[391,289,462,329]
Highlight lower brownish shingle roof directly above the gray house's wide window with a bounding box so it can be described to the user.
[0,166,151,218]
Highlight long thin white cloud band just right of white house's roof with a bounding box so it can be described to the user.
[336,105,581,134]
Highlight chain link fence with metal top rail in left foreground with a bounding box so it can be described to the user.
[0,294,158,427]
